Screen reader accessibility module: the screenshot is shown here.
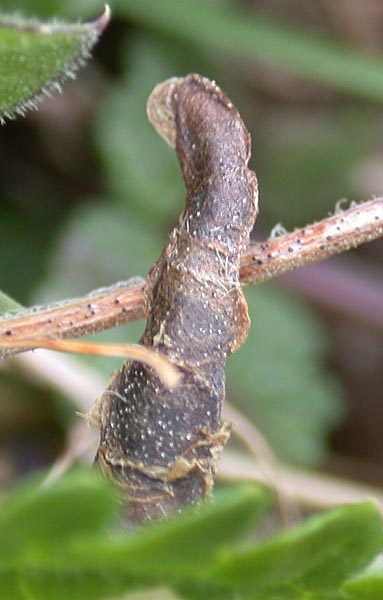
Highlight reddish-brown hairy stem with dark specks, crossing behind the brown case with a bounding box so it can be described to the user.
[0,197,383,357]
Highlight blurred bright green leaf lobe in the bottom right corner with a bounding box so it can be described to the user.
[210,502,383,599]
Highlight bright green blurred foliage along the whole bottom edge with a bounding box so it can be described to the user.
[0,471,382,600]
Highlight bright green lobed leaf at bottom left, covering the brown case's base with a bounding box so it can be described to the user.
[0,471,270,600]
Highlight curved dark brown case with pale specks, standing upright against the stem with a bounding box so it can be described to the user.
[97,75,257,522]
